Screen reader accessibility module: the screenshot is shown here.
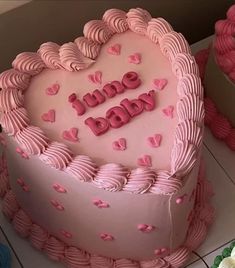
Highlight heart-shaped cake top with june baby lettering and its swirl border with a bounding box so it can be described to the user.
[0,8,204,192]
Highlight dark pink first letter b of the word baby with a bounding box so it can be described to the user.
[85,117,109,136]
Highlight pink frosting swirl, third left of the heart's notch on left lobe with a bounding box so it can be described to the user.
[12,52,46,75]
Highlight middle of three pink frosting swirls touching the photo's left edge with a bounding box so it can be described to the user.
[0,88,24,112]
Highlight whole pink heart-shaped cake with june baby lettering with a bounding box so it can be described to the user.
[0,8,213,268]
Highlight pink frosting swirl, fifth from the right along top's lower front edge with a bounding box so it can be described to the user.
[39,142,72,169]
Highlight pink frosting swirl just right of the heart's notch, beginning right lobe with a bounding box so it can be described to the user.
[74,36,100,59]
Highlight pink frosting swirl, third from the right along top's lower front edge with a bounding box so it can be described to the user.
[93,164,128,192]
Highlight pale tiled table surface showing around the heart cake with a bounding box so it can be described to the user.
[0,37,235,268]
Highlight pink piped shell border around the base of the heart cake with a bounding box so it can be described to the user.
[0,159,214,268]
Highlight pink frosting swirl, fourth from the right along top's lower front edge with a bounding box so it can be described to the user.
[65,155,97,181]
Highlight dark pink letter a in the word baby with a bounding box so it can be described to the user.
[106,106,130,128]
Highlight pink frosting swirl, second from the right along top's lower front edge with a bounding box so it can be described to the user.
[123,168,156,194]
